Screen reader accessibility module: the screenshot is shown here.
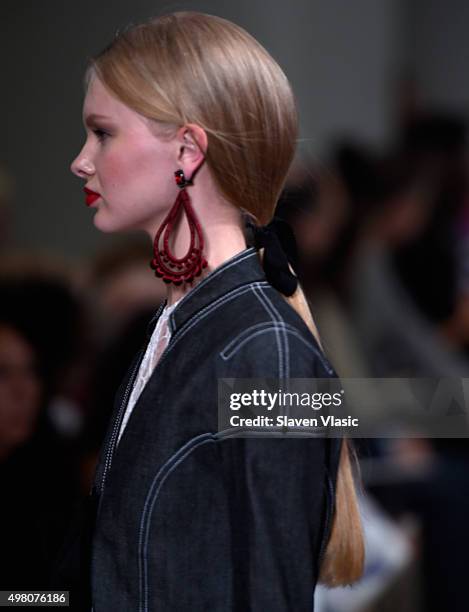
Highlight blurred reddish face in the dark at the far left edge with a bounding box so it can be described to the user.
[0,323,42,457]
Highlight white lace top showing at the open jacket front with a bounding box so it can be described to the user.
[117,300,179,444]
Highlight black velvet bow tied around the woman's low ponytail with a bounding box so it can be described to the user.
[247,217,298,296]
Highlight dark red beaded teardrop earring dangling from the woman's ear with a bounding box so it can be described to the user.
[150,170,207,285]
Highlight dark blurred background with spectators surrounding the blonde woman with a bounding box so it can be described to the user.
[0,0,469,612]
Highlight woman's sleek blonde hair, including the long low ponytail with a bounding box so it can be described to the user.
[88,12,363,585]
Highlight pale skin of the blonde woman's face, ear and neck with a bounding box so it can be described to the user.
[71,76,246,304]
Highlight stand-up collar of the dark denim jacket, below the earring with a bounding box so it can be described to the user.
[169,247,265,333]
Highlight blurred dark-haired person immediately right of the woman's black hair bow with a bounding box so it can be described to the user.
[275,165,369,377]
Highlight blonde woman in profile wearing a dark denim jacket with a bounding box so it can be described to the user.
[72,12,363,612]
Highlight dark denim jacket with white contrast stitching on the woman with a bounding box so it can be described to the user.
[92,248,340,612]
